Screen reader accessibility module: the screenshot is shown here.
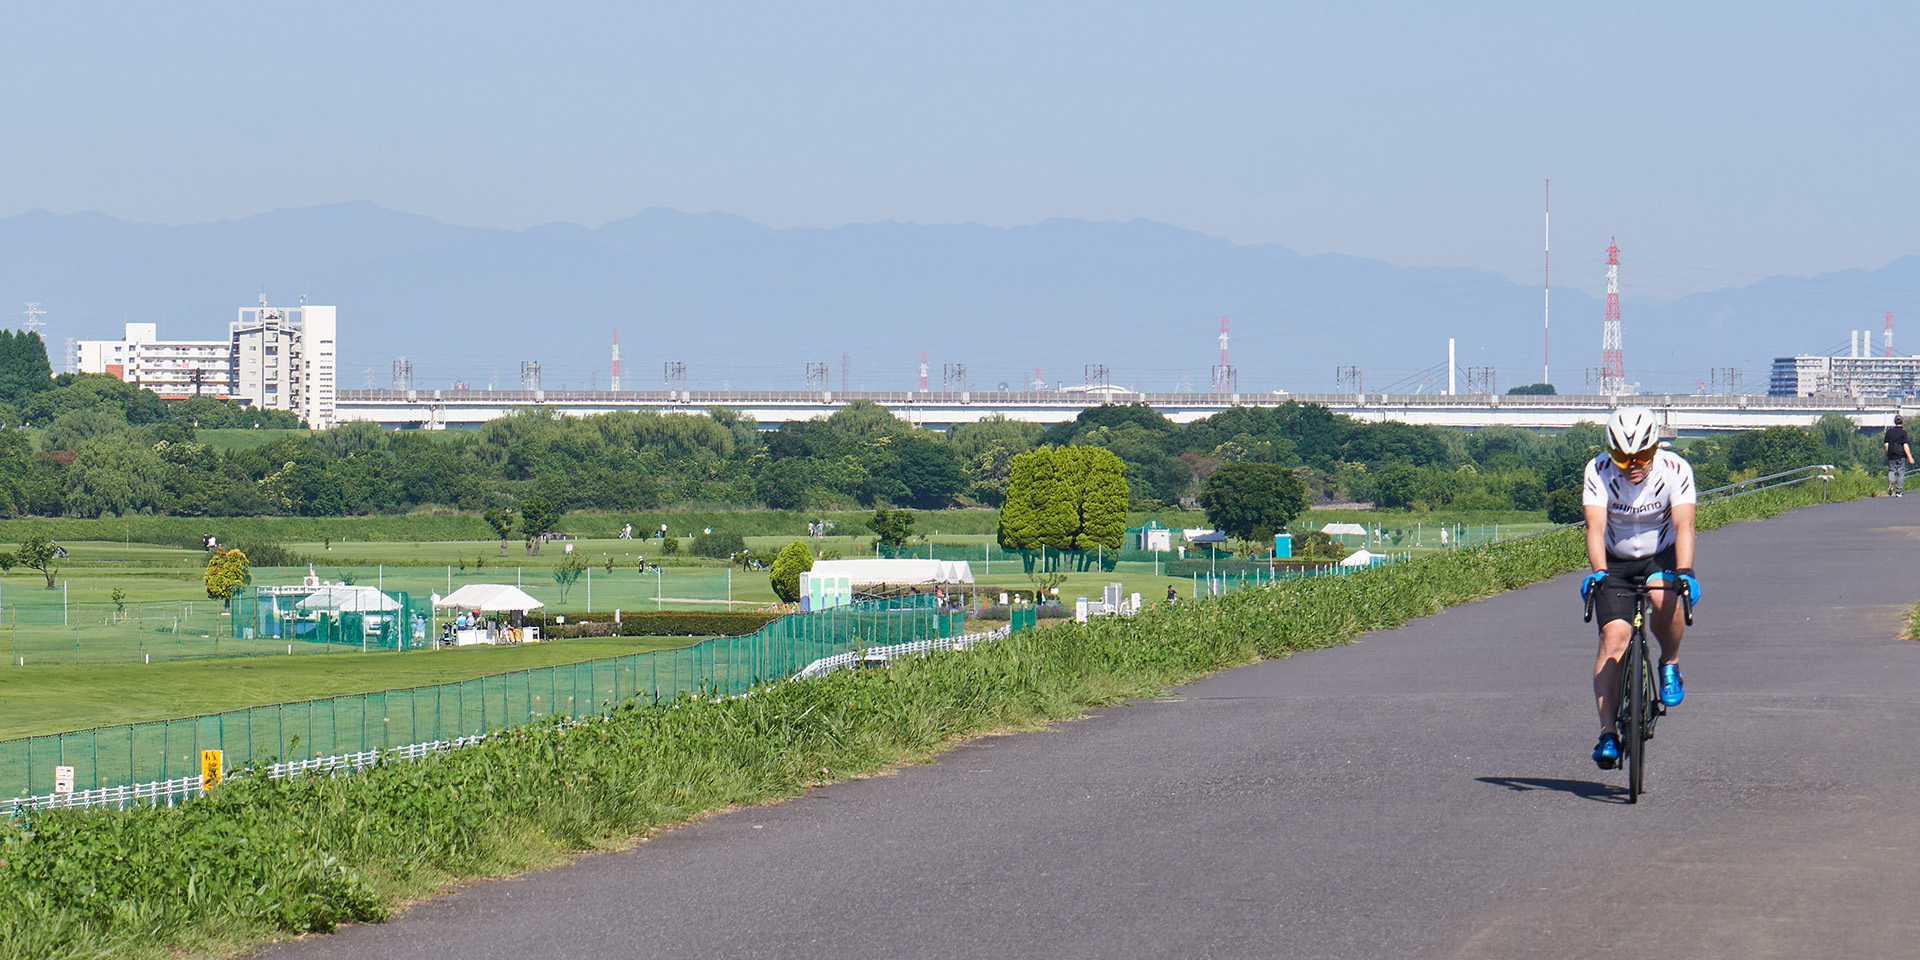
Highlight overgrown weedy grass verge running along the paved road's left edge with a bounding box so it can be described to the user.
[0,474,1874,958]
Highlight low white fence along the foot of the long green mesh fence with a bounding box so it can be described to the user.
[0,628,1008,816]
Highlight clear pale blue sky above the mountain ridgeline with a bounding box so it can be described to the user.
[0,0,1920,298]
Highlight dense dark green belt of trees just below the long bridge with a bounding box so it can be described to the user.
[0,320,1874,522]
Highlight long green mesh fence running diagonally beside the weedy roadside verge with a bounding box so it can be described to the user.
[0,597,962,797]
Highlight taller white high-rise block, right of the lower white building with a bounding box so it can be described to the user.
[228,298,338,430]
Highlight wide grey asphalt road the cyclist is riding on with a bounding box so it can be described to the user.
[263,497,1920,960]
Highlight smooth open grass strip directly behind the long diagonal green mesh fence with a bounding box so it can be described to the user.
[0,637,707,739]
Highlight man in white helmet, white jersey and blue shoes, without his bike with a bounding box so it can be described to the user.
[1580,407,1699,770]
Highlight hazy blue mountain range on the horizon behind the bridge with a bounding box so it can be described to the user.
[0,204,1920,394]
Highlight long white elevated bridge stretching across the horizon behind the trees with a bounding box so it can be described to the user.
[336,388,1920,436]
